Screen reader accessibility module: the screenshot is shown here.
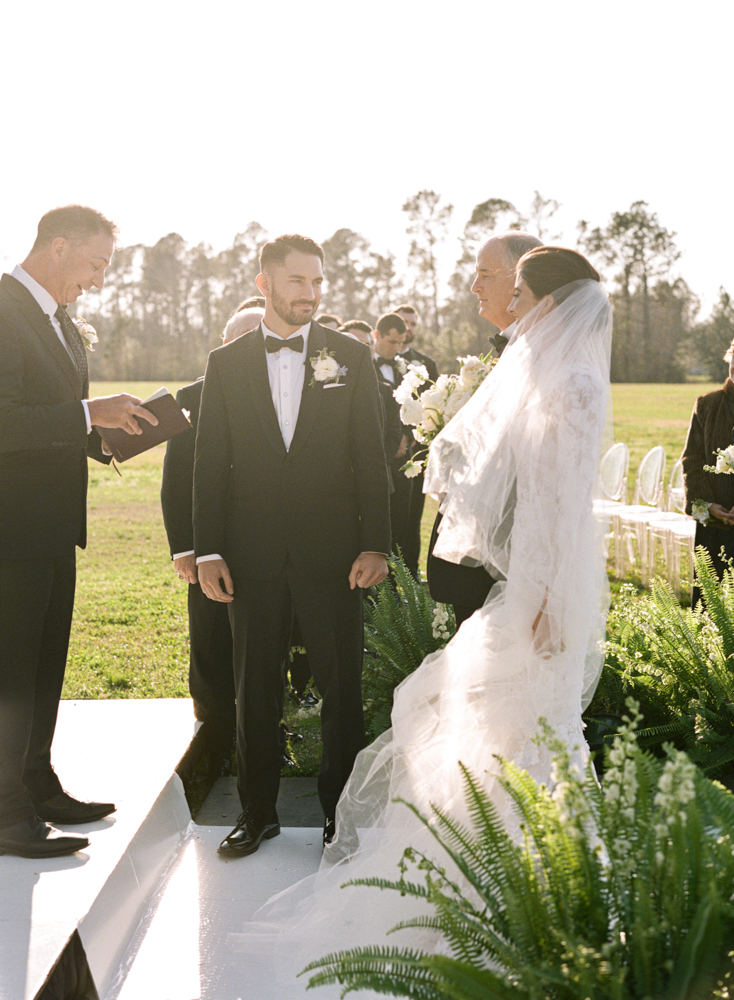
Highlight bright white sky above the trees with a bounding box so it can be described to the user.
[0,0,734,313]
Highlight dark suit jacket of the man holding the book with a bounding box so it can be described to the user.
[0,274,110,559]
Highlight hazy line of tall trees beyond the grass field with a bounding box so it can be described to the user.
[81,191,734,382]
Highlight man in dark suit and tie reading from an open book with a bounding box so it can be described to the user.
[0,205,157,858]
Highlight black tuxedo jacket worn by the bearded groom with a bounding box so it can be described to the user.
[194,323,390,580]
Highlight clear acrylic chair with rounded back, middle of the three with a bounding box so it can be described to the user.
[613,445,665,583]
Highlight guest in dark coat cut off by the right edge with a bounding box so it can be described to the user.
[683,341,734,607]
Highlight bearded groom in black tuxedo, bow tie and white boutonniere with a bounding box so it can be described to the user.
[194,235,390,857]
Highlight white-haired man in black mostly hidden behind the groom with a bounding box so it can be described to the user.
[161,299,264,774]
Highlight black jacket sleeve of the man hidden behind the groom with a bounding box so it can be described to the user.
[161,375,204,556]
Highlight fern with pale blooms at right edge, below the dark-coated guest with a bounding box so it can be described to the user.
[607,548,734,774]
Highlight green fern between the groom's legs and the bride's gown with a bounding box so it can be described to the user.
[362,556,456,738]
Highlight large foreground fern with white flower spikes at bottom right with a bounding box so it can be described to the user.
[302,702,734,1000]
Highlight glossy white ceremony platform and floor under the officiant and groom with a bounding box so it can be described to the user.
[0,699,328,1000]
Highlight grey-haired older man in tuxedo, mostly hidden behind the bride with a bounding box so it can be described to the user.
[428,230,542,628]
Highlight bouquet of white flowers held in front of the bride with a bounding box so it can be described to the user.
[393,354,497,478]
